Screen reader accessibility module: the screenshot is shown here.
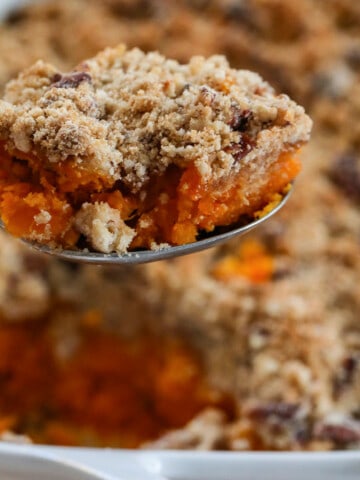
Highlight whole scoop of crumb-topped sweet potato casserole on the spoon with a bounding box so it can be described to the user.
[0,46,311,253]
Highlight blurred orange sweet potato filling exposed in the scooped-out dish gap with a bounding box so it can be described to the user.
[0,316,233,448]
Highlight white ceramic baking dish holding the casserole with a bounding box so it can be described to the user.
[0,0,360,480]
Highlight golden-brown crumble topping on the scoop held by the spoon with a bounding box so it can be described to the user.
[0,46,311,191]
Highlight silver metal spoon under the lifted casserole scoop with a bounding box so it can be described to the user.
[2,190,291,265]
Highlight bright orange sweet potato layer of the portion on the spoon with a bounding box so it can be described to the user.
[0,142,300,249]
